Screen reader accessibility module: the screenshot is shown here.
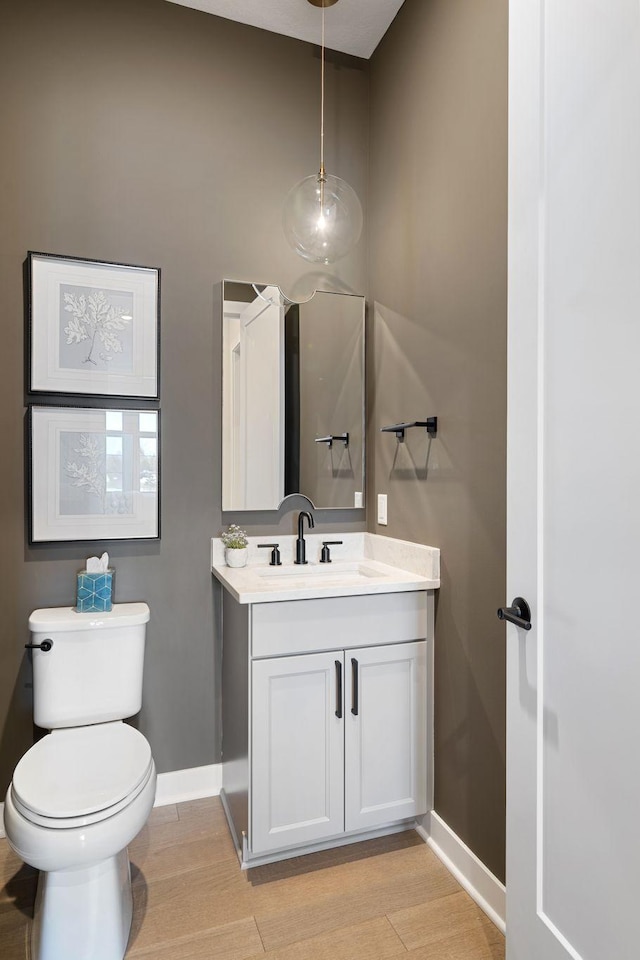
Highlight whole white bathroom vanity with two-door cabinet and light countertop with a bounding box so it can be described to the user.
[212,534,440,867]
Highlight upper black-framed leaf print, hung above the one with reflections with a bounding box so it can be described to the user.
[28,252,160,400]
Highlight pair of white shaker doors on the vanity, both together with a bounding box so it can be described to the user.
[251,640,427,853]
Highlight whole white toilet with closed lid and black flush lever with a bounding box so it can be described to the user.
[4,603,156,960]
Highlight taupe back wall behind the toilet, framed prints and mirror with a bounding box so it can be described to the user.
[0,0,368,792]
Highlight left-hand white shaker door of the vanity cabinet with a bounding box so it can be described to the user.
[250,651,344,854]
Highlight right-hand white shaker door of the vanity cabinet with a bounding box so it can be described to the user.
[345,640,427,830]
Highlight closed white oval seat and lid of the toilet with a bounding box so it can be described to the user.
[11,721,154,829]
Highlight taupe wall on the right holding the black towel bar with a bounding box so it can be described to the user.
[367,0,508,877]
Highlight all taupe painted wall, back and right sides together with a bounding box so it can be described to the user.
[0,0,507,876]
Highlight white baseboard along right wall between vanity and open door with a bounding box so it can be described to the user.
[417,811,506,933]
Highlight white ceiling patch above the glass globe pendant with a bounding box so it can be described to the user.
[169,0,404,59]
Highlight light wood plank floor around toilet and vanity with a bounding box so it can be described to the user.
[0,798,504,960]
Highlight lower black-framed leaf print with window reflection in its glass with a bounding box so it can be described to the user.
[28,406,160,543]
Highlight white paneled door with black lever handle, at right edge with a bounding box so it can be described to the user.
[505,0,640,960]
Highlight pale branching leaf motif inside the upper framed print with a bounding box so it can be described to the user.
[63,290,131,366]
